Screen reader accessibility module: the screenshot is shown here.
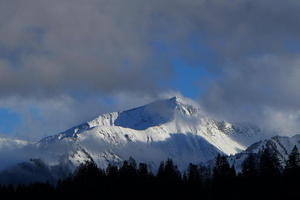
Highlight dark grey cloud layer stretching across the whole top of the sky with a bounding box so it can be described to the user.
[0,0,300,95]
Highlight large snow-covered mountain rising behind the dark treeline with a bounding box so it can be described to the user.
[36,97,264,167]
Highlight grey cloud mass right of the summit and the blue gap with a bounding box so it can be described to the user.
[202,54,300,134]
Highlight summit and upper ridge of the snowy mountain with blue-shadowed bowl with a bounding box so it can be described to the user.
[61,96,201,136]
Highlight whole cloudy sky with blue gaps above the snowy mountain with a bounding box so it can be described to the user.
[0,0,300,140]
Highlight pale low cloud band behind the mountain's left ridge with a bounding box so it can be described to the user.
[0,93,173,141]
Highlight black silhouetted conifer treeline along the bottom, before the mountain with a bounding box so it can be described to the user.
[0,146,300,199]
